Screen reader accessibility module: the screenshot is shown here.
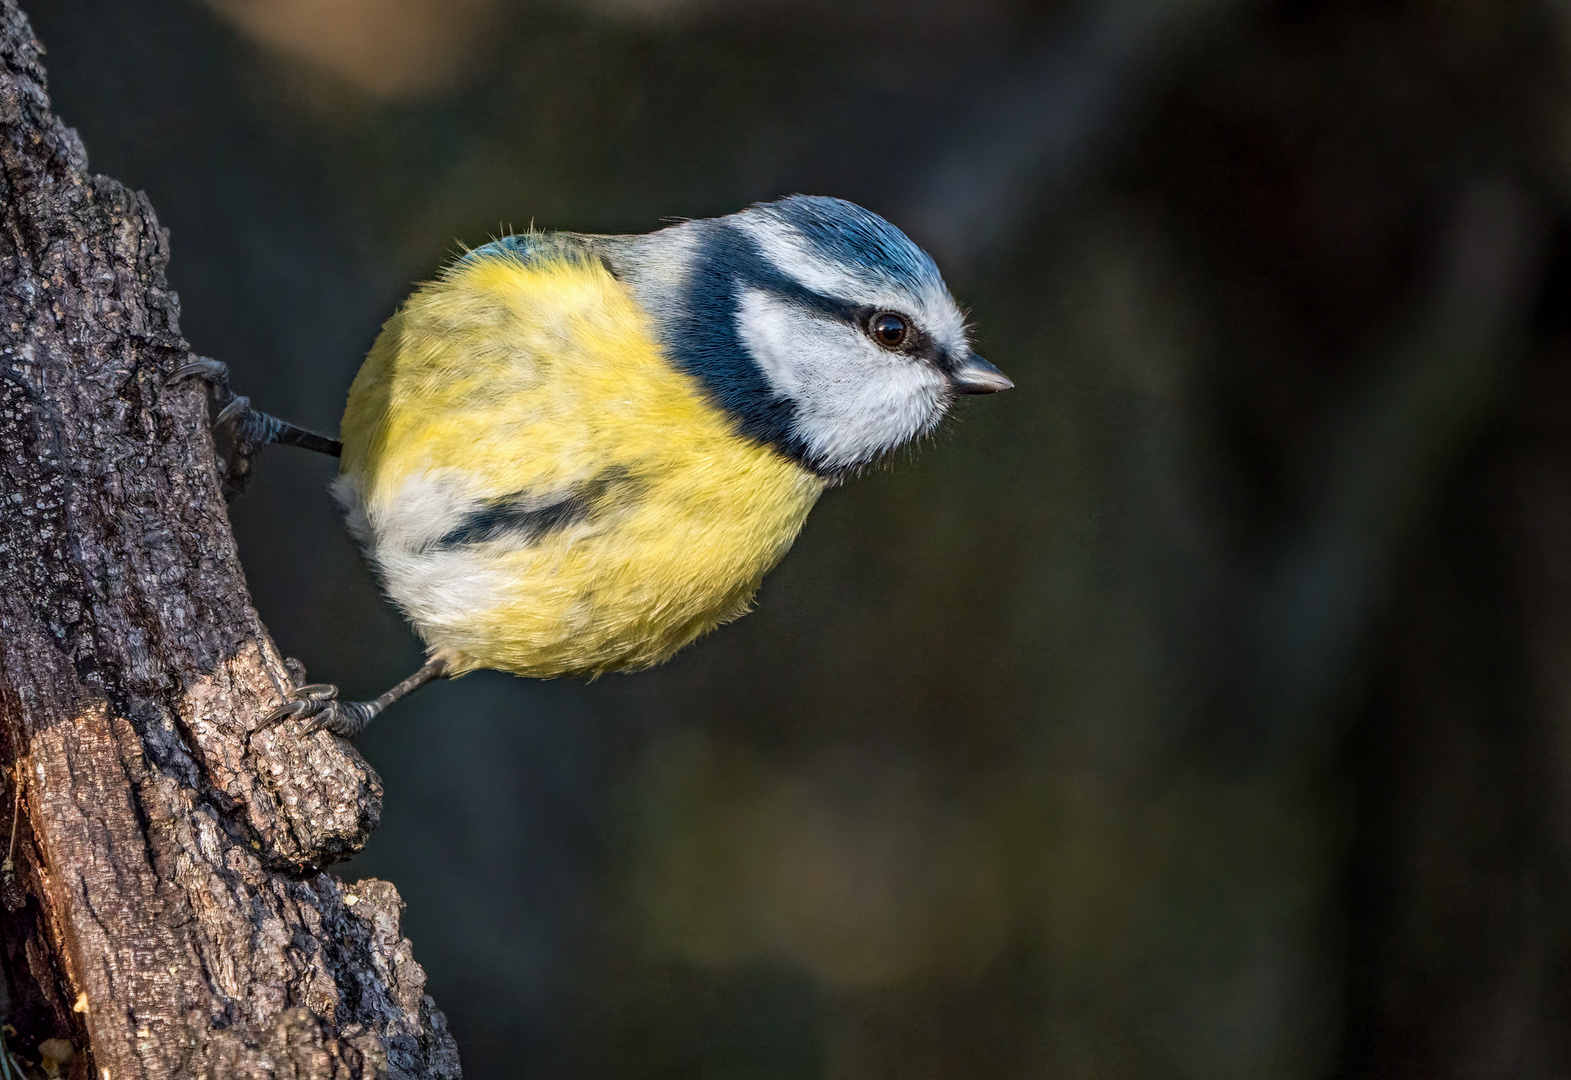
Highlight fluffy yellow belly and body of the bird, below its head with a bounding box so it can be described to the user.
[338,255,823,676]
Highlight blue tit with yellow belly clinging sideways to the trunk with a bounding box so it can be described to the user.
[176,195,1013,737]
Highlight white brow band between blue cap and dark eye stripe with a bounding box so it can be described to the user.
[737,214,971,355]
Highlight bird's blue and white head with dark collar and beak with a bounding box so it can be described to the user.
[608,195,1013,478]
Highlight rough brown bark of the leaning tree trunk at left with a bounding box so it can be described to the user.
[0,0,459,1080]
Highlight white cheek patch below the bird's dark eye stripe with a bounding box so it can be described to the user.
[737,289,949,468]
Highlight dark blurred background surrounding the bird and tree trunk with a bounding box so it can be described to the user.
[24,0,1571,1080]
